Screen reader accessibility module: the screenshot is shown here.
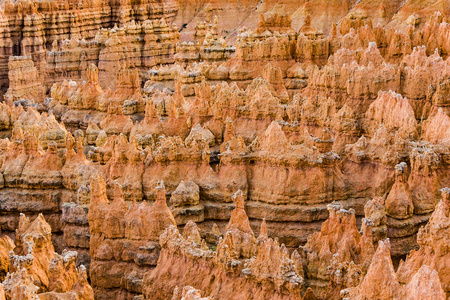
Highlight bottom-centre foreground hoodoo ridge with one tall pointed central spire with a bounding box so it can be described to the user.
[143,191,304,299]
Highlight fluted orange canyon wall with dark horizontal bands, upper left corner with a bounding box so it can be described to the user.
[0,0,179,96]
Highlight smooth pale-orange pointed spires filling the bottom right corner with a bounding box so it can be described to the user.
[341,188,449,299]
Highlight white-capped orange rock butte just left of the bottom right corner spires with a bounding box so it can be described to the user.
[301,203,374,297]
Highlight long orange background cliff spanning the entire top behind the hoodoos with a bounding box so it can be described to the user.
[0,0,449,97]
